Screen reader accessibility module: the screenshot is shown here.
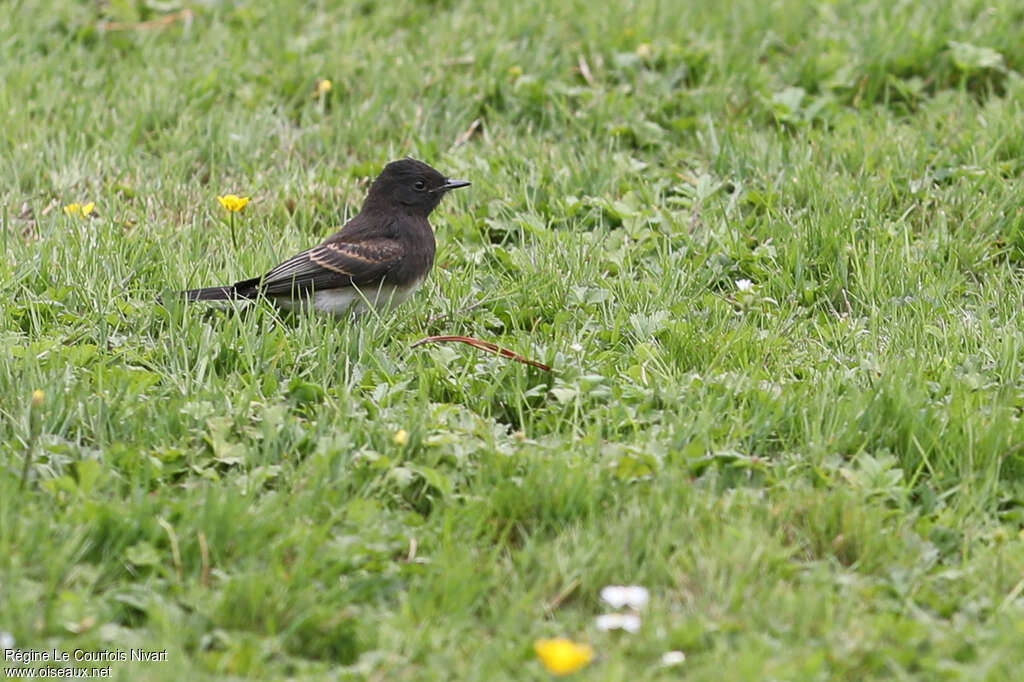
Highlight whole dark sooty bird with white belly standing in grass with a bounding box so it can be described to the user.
[181,159,469,315]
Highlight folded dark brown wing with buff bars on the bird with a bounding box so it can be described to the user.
[261,239,404,295]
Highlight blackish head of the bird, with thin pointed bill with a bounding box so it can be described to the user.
[362,159,469,218]
